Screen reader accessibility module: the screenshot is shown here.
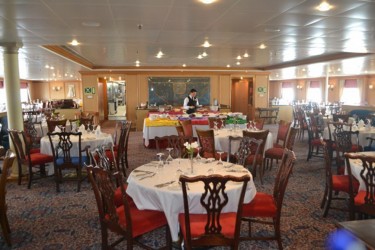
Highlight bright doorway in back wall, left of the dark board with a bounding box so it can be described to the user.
[107,81,126,120]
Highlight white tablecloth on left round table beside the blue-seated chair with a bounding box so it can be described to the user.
[40,133,113,157]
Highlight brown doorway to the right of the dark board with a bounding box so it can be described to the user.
[231,77,254,120]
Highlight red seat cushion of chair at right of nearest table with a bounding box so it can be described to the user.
[242,192,277,217]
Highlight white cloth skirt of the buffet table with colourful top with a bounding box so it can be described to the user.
[143,123,209,147]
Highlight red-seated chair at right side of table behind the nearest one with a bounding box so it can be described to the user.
[264,127,298,168]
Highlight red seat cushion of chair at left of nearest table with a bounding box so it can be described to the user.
[116,205,167,238]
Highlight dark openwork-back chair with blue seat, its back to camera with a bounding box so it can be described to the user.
[48,132,90,192]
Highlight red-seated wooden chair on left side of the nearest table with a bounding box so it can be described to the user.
[87,166,171,249]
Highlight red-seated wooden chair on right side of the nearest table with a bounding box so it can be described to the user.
[240,149,296,249]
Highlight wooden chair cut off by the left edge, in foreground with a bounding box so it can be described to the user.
[0,150,16,246]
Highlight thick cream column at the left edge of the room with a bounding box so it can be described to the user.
[0,43,23,177]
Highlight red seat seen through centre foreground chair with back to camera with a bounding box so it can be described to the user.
[178,213,237,239]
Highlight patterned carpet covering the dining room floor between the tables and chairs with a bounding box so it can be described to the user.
[0,123,346,250]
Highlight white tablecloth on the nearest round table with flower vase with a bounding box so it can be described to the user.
[127,159,256,241]
